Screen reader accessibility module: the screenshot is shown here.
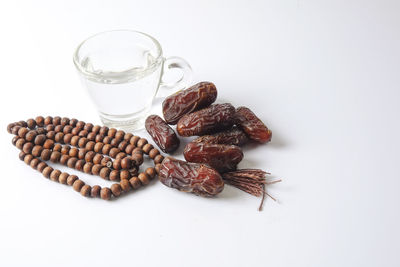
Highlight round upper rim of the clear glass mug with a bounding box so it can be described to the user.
[73,29,163,78]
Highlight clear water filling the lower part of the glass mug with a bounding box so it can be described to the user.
[82,52,162,124]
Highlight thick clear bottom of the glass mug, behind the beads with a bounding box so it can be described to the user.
[99,107,150,132]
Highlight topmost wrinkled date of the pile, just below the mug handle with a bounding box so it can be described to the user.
[162,82,217,124]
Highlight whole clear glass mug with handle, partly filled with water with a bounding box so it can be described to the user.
[73,30,192,131]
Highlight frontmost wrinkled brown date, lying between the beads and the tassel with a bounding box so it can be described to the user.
[158,157,224,197]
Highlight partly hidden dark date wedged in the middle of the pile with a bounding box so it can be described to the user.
[192,126,249,146]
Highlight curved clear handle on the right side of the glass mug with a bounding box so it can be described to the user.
[157,57,193,97]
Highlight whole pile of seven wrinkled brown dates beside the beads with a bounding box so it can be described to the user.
[145,82,272,196]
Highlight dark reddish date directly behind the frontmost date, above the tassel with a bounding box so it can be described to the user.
[183,142,243,173]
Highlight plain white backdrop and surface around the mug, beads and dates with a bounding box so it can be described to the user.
[0,0,400,266]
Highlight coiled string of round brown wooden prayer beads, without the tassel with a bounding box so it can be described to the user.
[7,116,164,200]
